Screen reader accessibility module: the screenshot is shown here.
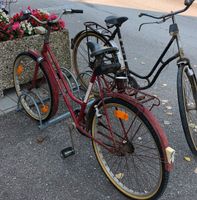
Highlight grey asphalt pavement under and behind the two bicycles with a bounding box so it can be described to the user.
[0,0,197,200]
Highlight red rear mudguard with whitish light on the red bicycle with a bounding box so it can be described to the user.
[87,93,174,171]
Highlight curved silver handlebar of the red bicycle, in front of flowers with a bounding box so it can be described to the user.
[20,9,83,25]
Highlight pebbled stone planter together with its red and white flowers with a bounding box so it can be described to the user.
[0,8,71,96]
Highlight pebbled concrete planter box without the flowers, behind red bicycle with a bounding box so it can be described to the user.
[0,30,71,97]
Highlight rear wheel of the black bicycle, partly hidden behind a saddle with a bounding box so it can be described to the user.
[72,31,111,94]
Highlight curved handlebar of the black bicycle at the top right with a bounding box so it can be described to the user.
[138,0,195,21]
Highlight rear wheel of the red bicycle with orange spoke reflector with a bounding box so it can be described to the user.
[92,98,169,199]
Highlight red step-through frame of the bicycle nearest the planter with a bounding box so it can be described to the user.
[34,26,137,152]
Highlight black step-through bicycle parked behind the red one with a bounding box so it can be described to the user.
[72,0,197,155]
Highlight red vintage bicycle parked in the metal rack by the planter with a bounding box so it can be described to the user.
[14,10,174,199]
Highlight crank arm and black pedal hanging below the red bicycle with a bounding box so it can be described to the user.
[61,123,75,159]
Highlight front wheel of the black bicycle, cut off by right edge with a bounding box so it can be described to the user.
[177,66,197,155]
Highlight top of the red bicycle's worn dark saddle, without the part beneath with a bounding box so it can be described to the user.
[87,42,118,57]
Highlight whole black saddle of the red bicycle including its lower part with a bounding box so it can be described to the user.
[87,42,121,76]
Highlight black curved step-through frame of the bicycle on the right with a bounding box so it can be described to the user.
[84,13,191,90]
